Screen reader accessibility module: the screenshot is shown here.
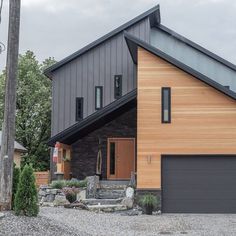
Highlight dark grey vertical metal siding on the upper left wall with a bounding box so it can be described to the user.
[52,17,150,136]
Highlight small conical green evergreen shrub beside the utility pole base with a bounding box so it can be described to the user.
[14,164,39,216]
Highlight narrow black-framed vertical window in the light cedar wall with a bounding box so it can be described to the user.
[161,88,171,123]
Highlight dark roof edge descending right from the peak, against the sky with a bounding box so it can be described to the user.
[154,24,236,71]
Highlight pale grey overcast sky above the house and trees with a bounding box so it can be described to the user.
[0,0,236,71]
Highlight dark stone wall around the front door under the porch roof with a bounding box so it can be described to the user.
[71,108,137,179]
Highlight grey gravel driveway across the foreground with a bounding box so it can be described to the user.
[0,207,236,236]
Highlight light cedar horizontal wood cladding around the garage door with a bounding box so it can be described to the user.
[137,48,236,189]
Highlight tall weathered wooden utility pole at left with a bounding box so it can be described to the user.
[0,0,21,210]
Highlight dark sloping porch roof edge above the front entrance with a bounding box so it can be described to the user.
[48,89,137,147]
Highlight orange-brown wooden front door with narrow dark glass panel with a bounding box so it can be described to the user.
[107,138,135,179]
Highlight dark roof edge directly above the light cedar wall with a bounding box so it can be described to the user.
[124,32,236,100]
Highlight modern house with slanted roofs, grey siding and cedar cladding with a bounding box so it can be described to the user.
[45,5,236,213]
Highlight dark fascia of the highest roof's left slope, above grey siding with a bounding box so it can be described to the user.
[44,4,161,78]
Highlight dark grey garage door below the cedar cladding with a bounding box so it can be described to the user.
[162,155,236,213]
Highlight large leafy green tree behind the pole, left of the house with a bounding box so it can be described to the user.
[0,51,55,171]
